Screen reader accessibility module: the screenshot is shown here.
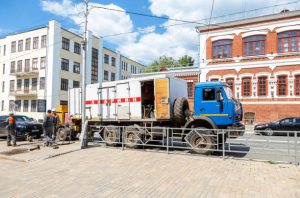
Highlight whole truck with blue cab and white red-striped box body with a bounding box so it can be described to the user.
[69,75,244,154]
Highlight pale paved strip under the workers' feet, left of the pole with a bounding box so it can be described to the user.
[0,139,80,162]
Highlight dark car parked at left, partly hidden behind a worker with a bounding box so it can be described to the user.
[0,115,43,138]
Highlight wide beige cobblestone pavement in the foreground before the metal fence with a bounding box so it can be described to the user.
[0,147,300,197]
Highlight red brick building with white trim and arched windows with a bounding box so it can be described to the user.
[197,11,300,123]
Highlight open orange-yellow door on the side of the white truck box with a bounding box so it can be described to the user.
[155,78,170,119]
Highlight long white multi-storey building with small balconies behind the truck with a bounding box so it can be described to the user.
[0,21,144,119]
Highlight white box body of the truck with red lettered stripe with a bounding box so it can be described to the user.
[68,74,188,121]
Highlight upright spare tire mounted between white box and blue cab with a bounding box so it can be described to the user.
[173,97,190,124]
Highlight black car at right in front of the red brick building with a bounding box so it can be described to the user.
[254,117,300,136]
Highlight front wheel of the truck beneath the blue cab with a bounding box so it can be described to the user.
[187,128,217,155]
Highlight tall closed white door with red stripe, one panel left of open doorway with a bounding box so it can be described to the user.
[116,83,130,120]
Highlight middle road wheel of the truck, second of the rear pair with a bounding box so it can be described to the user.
[125,126,142,148]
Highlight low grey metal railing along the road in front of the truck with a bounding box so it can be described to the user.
[90,125,300,165]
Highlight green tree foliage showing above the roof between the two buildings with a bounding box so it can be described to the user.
[144,55,194,72]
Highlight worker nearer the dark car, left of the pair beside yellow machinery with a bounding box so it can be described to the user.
[43,110,54,146]
